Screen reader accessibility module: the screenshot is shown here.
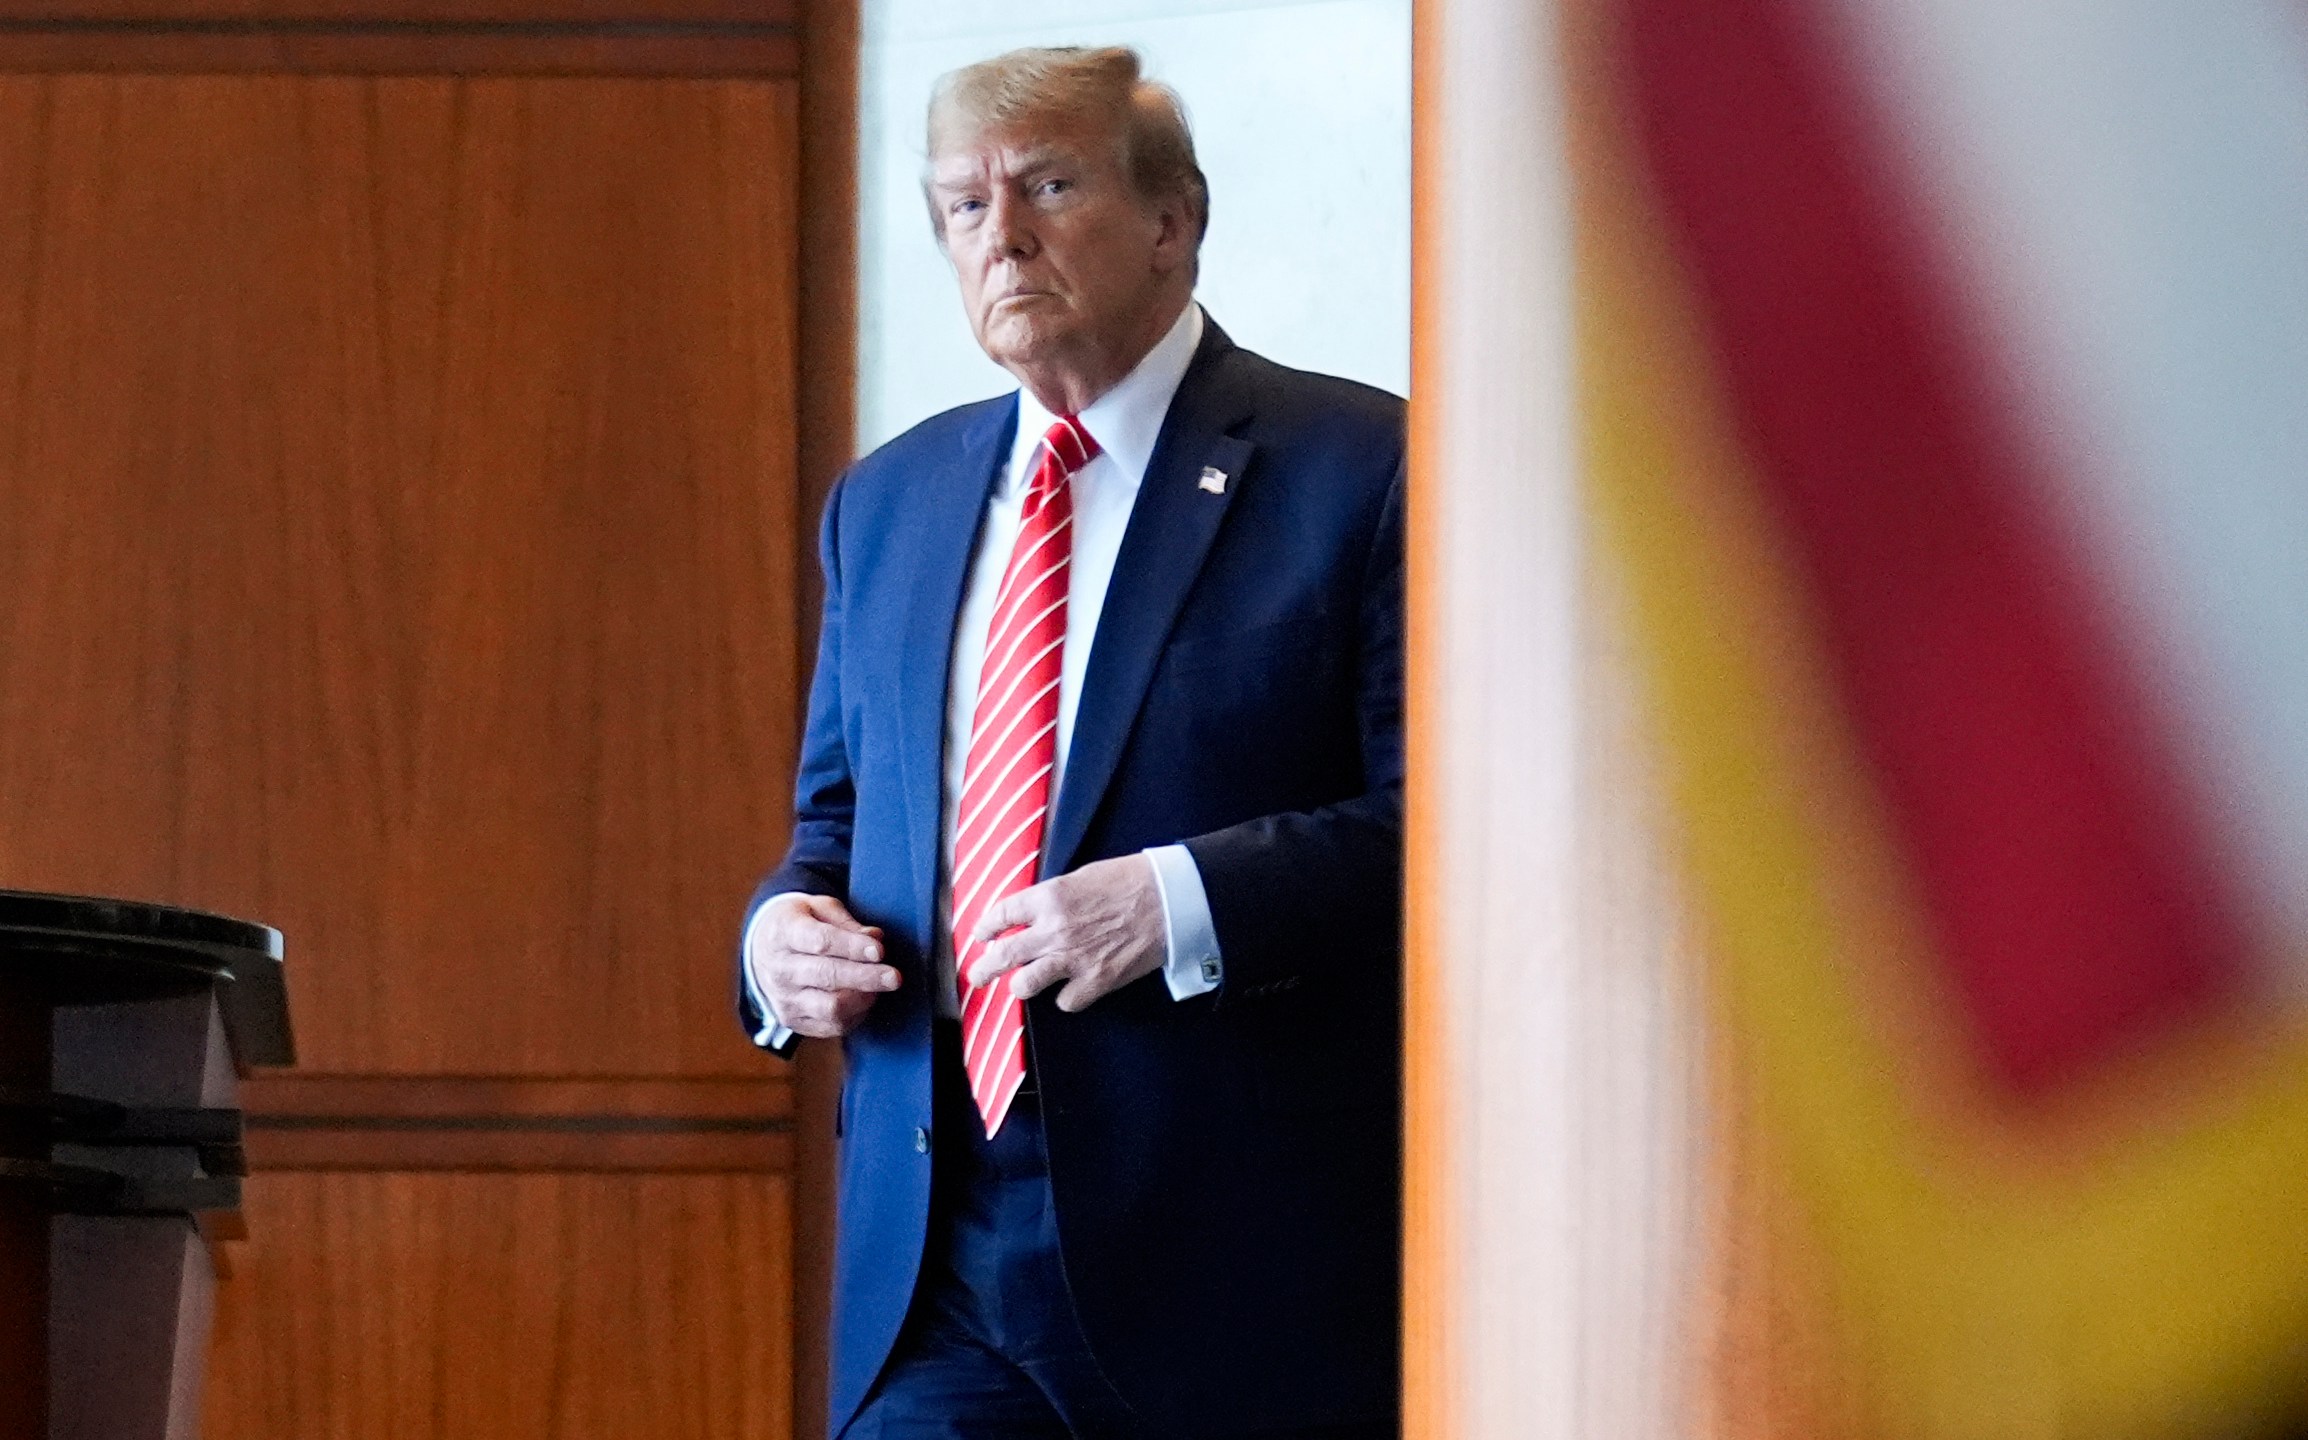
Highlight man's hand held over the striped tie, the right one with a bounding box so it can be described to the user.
[969,854,1170,1011]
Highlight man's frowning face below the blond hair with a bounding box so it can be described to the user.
[930,118,1191,380]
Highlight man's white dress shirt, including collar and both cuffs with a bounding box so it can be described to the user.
[745,300,1223,1045]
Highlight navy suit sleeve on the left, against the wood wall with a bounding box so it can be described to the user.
[736,482,856,1055]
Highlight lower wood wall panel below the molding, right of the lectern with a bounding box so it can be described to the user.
[208,1172,789,1440]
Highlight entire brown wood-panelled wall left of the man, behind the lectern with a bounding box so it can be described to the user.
[0,0,830,1440]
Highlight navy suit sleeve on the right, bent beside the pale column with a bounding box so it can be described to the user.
[1186,466,1406,1002]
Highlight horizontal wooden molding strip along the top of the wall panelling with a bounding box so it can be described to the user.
[0,16,801,78]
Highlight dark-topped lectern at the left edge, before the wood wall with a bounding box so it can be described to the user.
[0,891,295,1440]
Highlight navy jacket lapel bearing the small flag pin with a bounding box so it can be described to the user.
[1041,323,1251,879]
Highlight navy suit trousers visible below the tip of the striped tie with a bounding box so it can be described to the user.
[842,1020,1394,1440]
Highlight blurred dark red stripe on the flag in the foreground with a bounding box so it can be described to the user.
[1620,0,2243,1089]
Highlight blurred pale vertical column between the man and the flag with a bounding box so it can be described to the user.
[1406,0,1703,1440]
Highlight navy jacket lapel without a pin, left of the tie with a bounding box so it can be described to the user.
[898,397,1018,932]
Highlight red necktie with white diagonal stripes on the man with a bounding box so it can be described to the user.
[953,415,1099,1140]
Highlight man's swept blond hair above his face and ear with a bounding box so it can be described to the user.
[923,46,1209,249]
